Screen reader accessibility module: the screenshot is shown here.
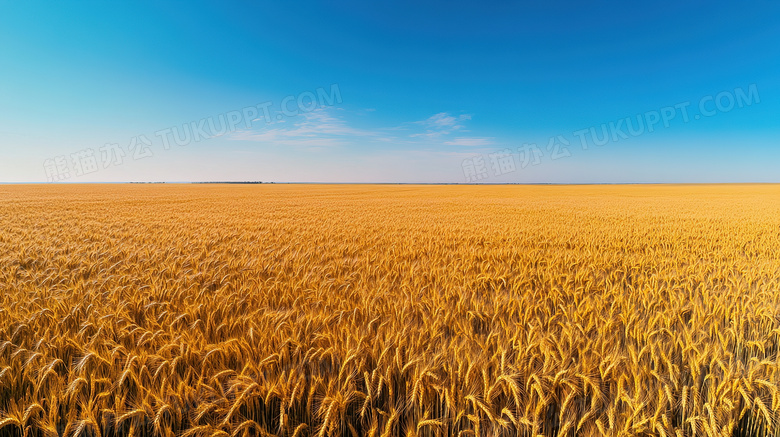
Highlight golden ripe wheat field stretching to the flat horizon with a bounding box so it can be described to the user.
[0,184,780,437]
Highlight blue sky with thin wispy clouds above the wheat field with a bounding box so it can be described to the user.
[0,0,780,183]
